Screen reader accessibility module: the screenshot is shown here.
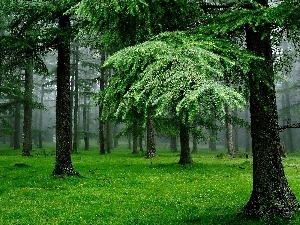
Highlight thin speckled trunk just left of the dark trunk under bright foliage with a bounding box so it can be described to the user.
[145,112,156,158]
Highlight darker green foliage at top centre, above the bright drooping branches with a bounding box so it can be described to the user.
[74,0,202,52]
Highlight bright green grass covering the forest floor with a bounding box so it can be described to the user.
[0,143,300,225]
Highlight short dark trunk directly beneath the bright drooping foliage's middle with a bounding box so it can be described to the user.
[178,123,192,165]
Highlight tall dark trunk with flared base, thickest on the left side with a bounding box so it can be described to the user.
[52,15,78,175]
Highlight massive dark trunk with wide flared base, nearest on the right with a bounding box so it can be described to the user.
[243,0,299,218]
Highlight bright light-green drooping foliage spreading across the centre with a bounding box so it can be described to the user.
[98,32,259,125]
